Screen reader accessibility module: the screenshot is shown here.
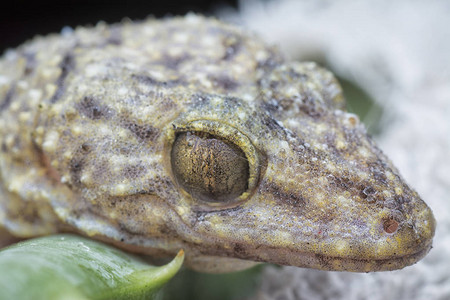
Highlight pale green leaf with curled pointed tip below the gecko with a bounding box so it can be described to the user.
[0,235,184,300]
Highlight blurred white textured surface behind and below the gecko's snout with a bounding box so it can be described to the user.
[224,0,450,300]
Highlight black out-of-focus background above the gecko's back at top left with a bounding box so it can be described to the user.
[0,0,237,52]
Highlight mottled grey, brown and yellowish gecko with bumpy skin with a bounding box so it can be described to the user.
[0,15,435,272]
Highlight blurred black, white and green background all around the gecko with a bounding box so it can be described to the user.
[0,0,450,300]
